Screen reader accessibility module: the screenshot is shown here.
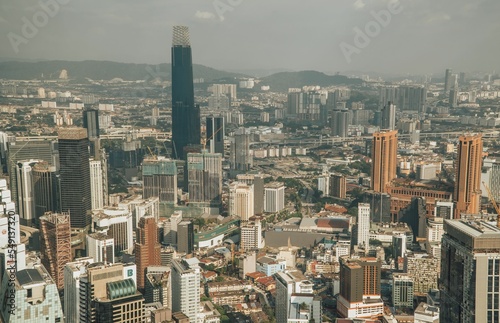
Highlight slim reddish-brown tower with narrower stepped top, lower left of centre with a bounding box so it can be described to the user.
[135,216,161,290]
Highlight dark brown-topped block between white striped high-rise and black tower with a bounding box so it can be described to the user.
[31,161,61,225]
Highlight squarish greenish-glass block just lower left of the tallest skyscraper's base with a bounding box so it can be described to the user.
[142,156,177,205]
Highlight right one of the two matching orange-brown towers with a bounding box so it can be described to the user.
[453,134,483,219]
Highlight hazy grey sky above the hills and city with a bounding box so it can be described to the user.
[0,0,500,74]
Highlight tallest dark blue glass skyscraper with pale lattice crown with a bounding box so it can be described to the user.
[172,26,201,158]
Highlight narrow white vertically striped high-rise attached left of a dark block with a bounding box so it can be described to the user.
[16,160,38,226]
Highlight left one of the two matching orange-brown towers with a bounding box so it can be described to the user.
[371,130,398,193]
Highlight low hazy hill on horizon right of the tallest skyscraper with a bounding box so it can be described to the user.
[261,71,363,91]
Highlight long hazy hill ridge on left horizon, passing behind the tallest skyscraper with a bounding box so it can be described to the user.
[0,61,245,82]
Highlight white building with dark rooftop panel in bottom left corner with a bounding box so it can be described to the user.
[0,264,64,323]
